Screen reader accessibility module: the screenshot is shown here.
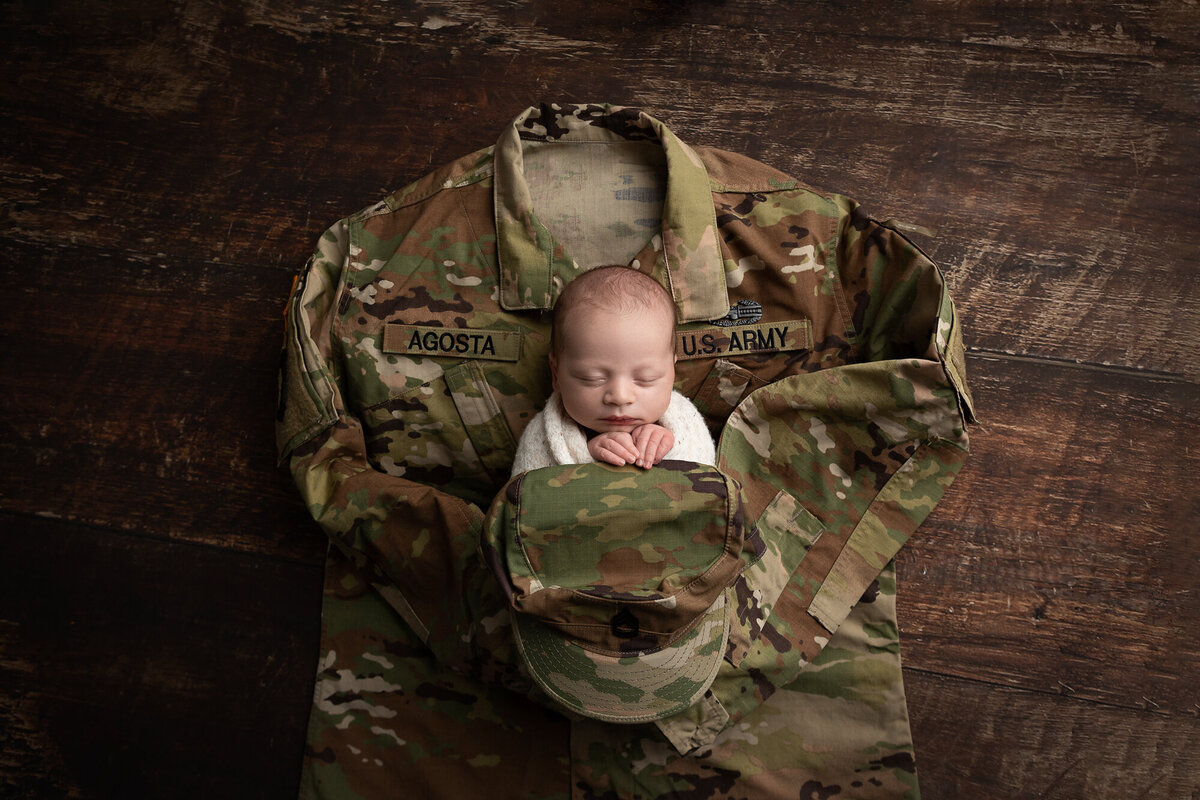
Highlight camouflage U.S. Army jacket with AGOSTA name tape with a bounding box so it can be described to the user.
[276,106,973,800]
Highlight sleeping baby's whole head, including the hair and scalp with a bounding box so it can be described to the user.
[550,266,676,432]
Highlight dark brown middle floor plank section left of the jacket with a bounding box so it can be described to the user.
[0,241,323,561]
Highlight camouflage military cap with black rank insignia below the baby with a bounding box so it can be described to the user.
[484,462,744,722]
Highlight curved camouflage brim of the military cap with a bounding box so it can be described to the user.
[512,590,732,723]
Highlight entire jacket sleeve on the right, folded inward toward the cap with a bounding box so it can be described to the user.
[686,200,974,750]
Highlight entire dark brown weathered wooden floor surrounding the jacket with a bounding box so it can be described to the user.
[0,0,1200,800]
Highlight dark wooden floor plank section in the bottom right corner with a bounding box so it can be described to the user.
[905,669,1200,800]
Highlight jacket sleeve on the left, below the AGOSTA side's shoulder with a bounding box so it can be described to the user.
[276,219,484,661]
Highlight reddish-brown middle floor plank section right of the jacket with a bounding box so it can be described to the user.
[899,356,1200,720]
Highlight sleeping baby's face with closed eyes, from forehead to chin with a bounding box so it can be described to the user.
[550,306,676,433]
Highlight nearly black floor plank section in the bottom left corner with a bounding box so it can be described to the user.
[0,512,322,800]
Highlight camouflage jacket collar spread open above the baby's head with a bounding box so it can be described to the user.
[494,104,730,323]
